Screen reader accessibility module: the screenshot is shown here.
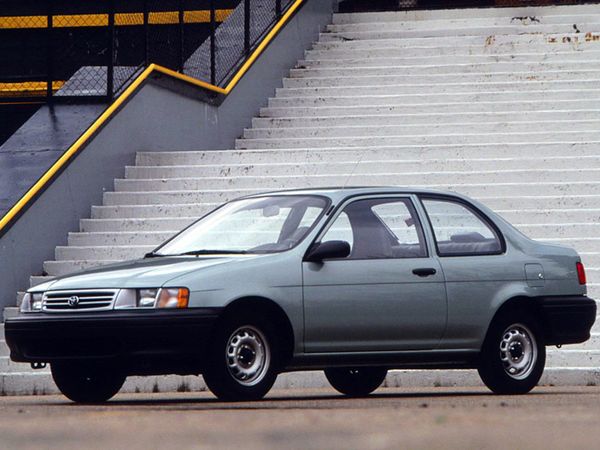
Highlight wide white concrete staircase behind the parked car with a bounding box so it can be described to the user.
[0,5,600,392]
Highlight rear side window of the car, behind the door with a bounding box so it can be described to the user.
[422,198,502,256]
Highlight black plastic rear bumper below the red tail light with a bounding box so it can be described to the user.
[538,296,596,345]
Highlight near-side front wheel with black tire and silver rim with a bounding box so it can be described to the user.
[203,314,281,401]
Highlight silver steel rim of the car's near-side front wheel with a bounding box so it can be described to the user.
[225,326,271,386]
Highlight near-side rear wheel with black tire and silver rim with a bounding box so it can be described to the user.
[478,311,546,395]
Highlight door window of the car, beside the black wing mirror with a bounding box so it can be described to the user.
[321,198,427,259]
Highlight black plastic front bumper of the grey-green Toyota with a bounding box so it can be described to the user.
[5,308,221,373]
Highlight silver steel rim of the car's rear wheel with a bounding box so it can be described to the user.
[500,323,537,380]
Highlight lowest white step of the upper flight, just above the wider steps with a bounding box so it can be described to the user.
[236,129,600,150]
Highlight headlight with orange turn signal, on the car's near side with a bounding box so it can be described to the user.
[115,288,190,309]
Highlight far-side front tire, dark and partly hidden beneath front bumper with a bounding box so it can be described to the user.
[50,361,126,403]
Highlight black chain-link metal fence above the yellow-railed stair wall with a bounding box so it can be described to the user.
[0,0,293,102]
